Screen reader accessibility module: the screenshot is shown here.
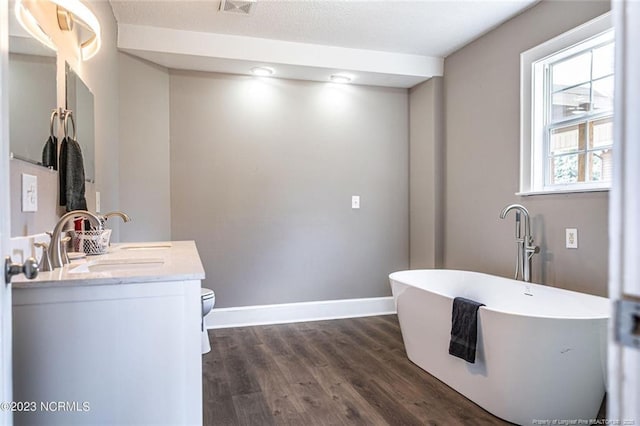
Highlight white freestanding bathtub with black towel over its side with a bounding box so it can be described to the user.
[389,269,609,425]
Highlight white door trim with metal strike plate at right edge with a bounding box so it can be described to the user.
[607,0,640,424]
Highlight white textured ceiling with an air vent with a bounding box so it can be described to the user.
[111,0,538,57]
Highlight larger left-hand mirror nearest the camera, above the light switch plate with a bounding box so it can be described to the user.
[9,36,58,165]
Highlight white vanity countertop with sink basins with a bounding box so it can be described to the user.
[12,241,205,289]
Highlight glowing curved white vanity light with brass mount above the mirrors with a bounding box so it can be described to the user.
[15,0,102,61]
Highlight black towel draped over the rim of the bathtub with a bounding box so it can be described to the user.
[449,297,484,364]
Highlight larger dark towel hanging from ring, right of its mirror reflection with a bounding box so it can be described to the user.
[58,137,87,212]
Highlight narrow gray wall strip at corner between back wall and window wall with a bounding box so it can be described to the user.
[409,77,445,269]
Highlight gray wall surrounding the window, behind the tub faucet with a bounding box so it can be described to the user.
[444,1,609,295]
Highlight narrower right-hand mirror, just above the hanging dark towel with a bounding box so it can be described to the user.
[65,62,96,182]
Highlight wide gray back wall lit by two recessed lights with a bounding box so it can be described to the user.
[170,71,409,307]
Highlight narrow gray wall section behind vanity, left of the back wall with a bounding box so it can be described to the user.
[118,53,171,241]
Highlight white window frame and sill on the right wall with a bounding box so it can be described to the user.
[517,13,615,195]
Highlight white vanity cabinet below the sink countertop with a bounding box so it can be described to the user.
[13,243,204,425]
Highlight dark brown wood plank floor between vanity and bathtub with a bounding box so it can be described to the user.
[203,315,508,426]
